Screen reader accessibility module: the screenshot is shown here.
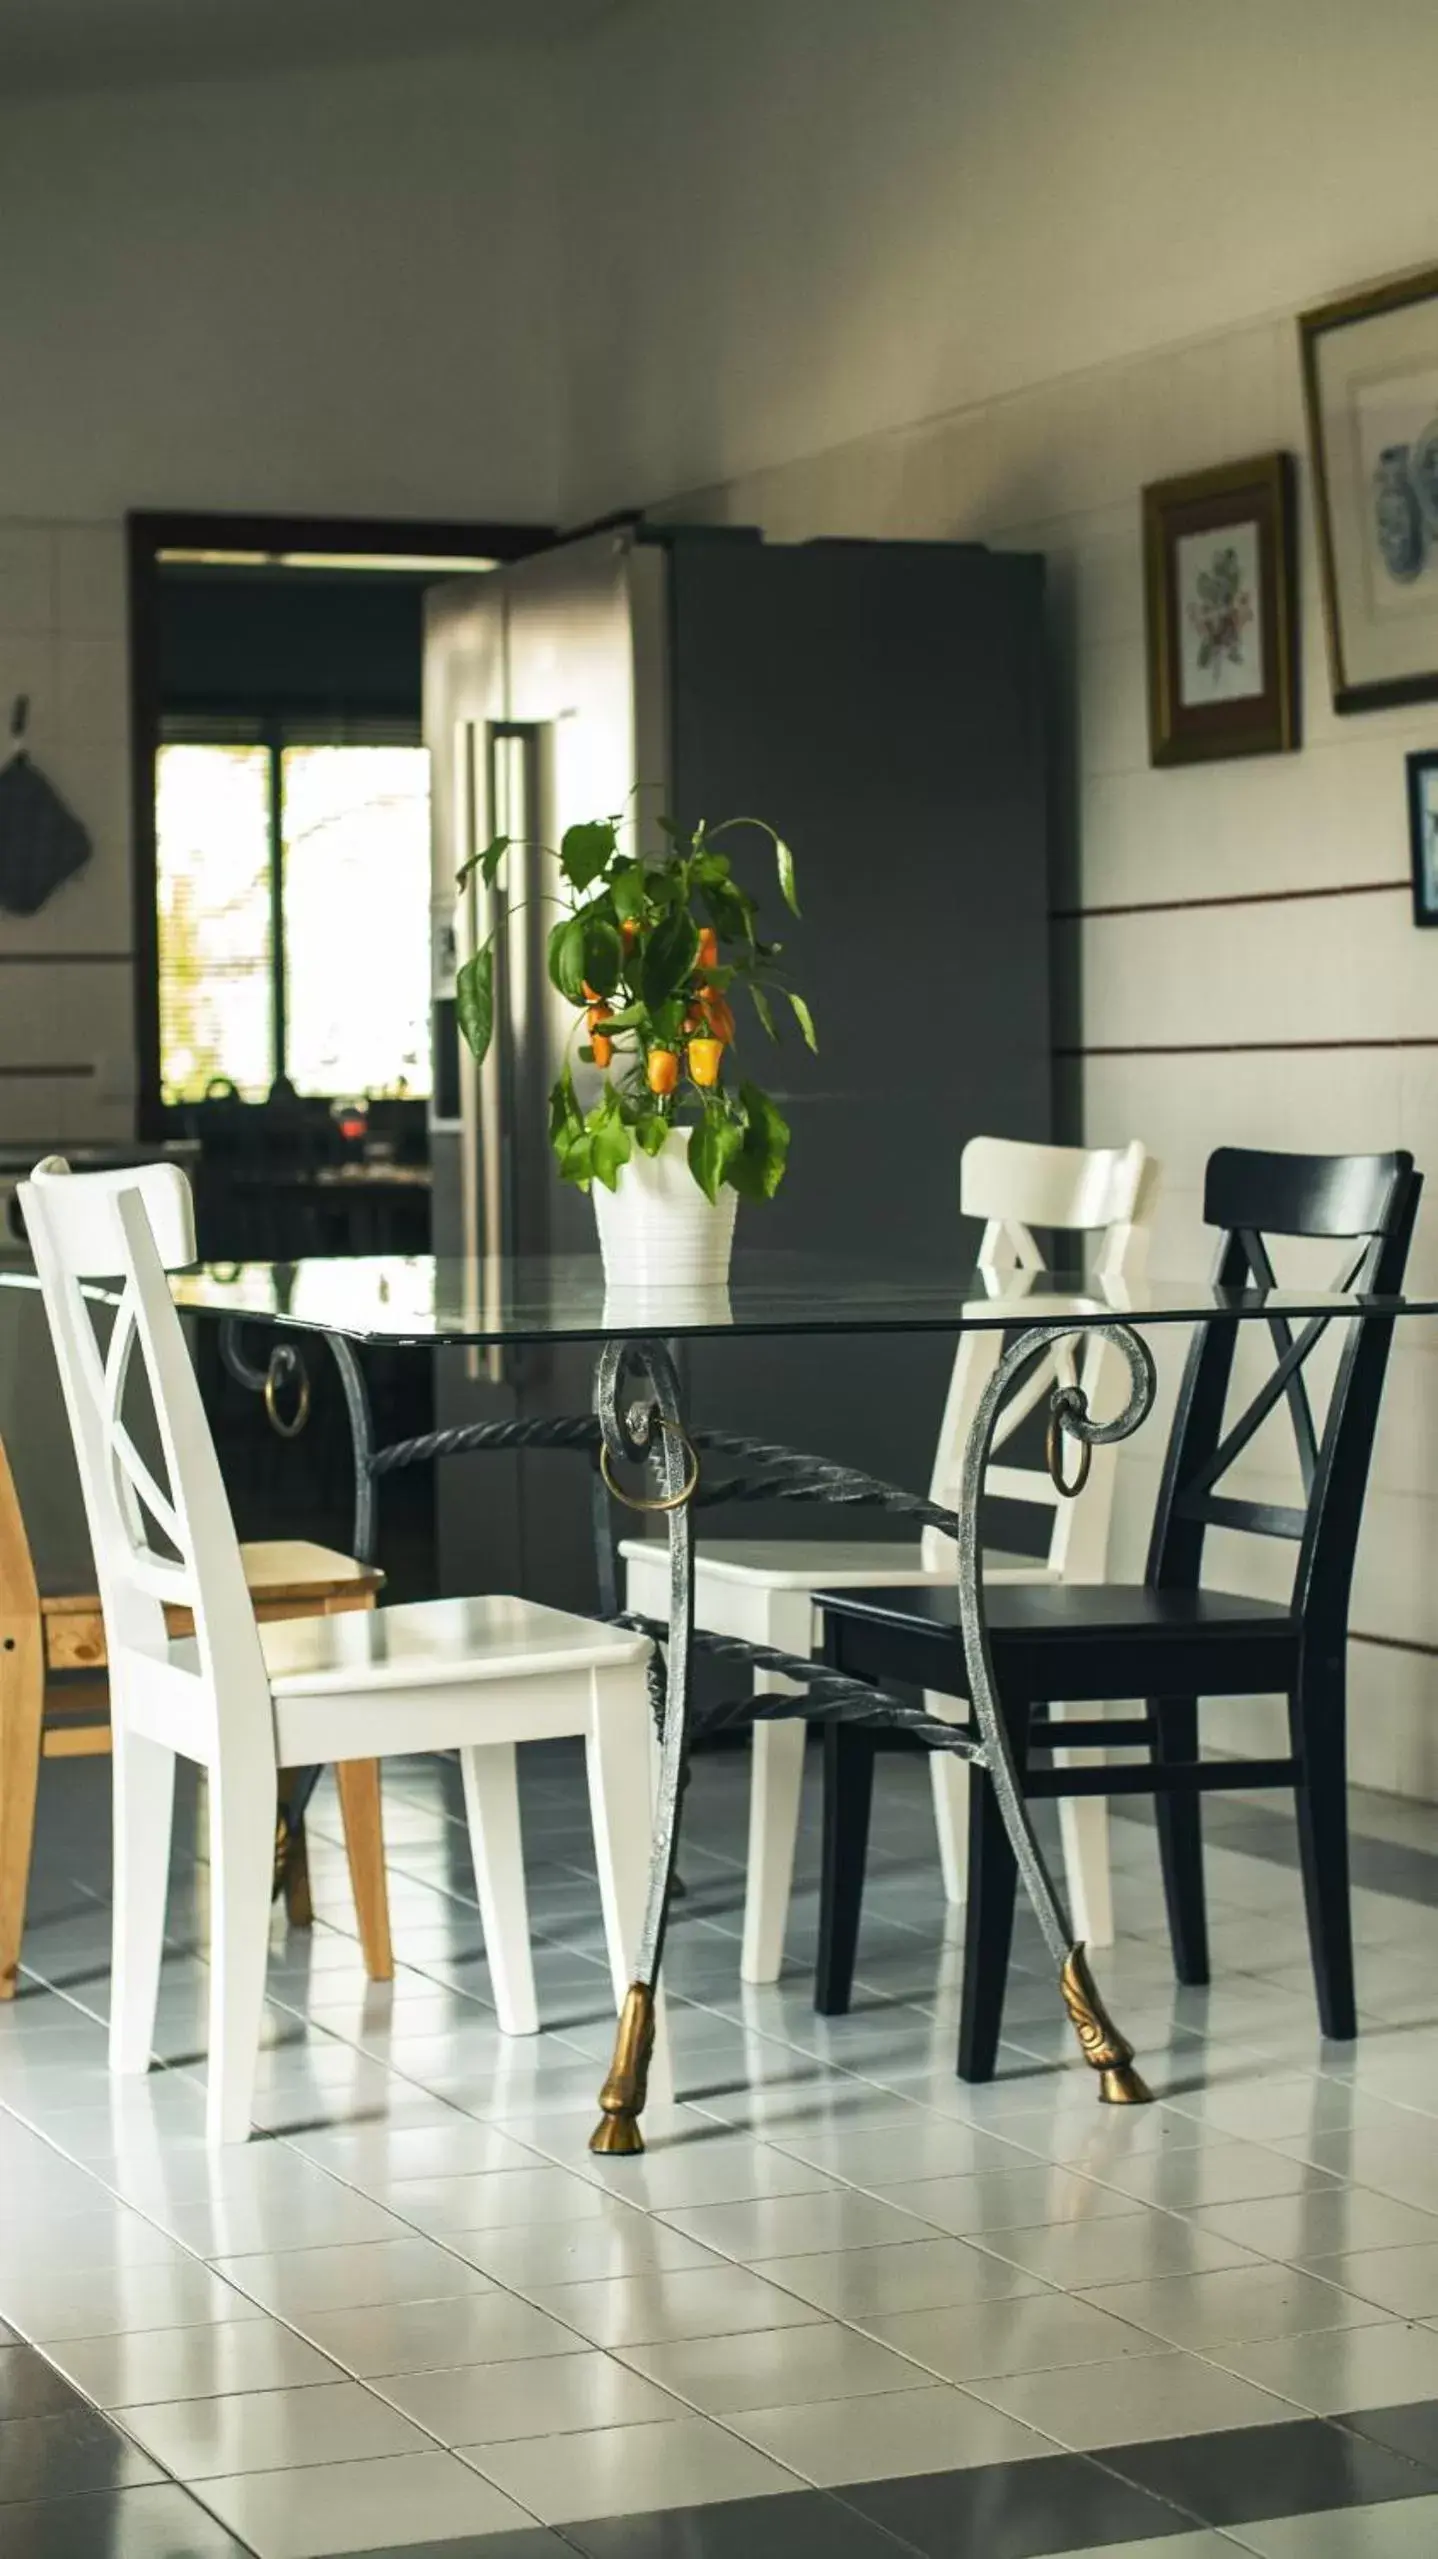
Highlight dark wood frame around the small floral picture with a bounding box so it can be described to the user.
[1144,453,1300,765]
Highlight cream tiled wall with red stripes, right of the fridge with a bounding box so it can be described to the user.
[673,320,1438,1796]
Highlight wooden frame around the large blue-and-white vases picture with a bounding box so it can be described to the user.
[1297,266,1438,711]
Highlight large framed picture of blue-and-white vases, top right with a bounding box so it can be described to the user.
[1297,266,1438,711]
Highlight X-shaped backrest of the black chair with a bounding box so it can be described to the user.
[1146,1146,1423,1640]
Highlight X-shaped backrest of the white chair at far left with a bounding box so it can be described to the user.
[20,1157,274,1755]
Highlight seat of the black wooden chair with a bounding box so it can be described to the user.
[816,1581,1300,1704]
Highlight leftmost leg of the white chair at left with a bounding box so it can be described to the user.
[110,1722,176,2073]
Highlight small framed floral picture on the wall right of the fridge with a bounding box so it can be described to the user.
[1144,453,1297,765]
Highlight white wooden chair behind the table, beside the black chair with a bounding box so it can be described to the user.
[622,1136,1159,1981]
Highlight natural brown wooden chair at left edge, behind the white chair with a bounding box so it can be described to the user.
[0,1441,394,1999]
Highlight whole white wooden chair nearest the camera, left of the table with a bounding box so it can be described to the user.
[20,1159,665,2142]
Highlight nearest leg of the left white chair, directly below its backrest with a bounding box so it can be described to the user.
[205,1763,279,2144]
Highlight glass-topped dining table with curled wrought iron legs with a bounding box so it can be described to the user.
[128,1254,1438,2152]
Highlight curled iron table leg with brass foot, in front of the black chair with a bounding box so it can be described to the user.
[957,1323,1154,2106]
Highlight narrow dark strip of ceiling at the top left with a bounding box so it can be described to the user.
[0,0,617,102]
